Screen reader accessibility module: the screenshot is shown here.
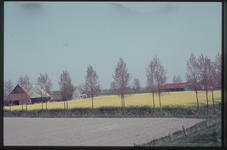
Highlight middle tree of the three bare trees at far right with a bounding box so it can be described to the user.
[198,54,213,115]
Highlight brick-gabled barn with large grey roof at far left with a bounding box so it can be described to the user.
[5,84,50,105]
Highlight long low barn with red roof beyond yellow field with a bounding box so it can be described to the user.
[161,82,192,91]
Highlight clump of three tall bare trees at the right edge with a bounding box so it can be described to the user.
[185,53,222,114]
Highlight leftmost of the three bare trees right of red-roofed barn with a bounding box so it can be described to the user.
[185,53,201,111]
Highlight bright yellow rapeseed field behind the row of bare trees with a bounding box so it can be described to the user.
[4,91,221,110]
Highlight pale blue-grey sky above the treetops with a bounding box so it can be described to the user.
[4,2,222,90]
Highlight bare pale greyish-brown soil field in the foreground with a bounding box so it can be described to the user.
[3,117,203,146]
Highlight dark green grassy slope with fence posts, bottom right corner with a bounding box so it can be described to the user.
[138,117,221,147]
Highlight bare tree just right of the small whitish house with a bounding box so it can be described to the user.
[83,65,101,114]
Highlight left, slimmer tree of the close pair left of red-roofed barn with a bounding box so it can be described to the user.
[146,60,158,112]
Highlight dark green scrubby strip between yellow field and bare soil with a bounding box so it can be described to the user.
[4,105,221,118]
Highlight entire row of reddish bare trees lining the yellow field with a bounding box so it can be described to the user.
[5,53,221,115]
